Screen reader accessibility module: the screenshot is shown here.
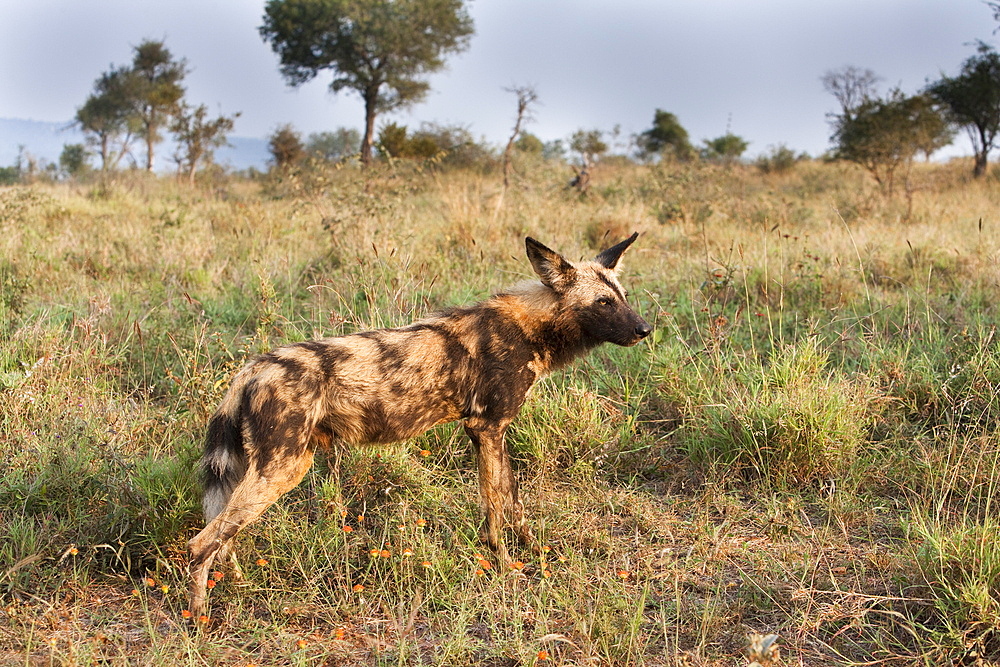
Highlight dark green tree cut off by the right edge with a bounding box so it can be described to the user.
[927,42,1000,178]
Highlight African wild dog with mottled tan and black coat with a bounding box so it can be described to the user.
[188,234,652,618]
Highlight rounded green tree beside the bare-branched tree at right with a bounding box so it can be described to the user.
[832,90,946,195]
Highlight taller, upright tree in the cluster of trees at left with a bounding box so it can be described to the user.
[127,40,187,172]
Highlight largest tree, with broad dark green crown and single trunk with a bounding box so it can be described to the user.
[259,0,473,165]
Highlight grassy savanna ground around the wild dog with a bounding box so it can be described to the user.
[0,154,1000,667]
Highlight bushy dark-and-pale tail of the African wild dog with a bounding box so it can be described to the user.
[201,371,249,523]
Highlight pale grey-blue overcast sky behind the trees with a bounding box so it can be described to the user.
[0,0,1000,160]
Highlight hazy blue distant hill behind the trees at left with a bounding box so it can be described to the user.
[0,118,270,171]
